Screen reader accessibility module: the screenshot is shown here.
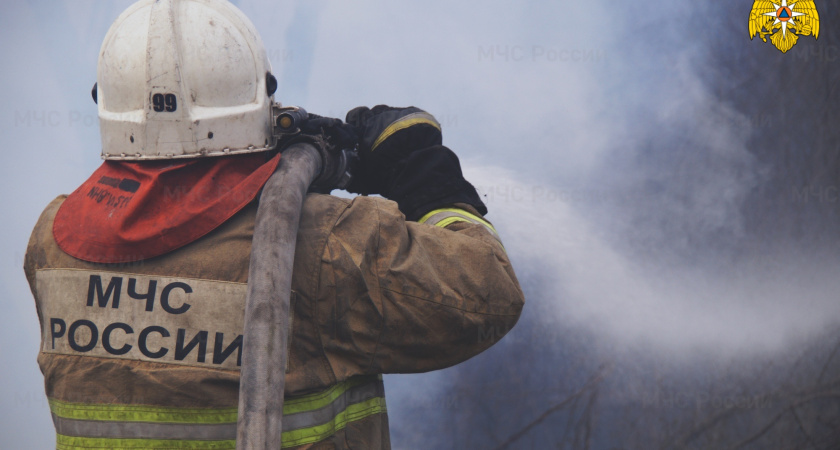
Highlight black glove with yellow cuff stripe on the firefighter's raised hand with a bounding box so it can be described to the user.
[347,105,487,220]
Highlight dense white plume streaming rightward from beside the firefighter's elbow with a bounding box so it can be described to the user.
[465,163,840,357]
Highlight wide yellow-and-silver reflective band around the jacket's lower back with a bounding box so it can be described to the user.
[50,375,386,449]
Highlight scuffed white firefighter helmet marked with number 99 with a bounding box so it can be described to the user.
[93,0,277,160]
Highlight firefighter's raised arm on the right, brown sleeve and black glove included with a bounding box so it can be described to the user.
[294,106,524,379]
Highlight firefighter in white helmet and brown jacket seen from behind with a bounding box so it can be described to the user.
[24,0,524,449]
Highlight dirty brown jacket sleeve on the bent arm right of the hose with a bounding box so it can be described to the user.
[299,196,524,380]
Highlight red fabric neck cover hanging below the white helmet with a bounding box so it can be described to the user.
[53,153,280,263]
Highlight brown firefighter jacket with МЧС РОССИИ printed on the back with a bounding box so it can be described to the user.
[25,194,524,449]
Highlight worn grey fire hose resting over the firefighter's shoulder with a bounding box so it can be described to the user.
[236,109,353,450]
